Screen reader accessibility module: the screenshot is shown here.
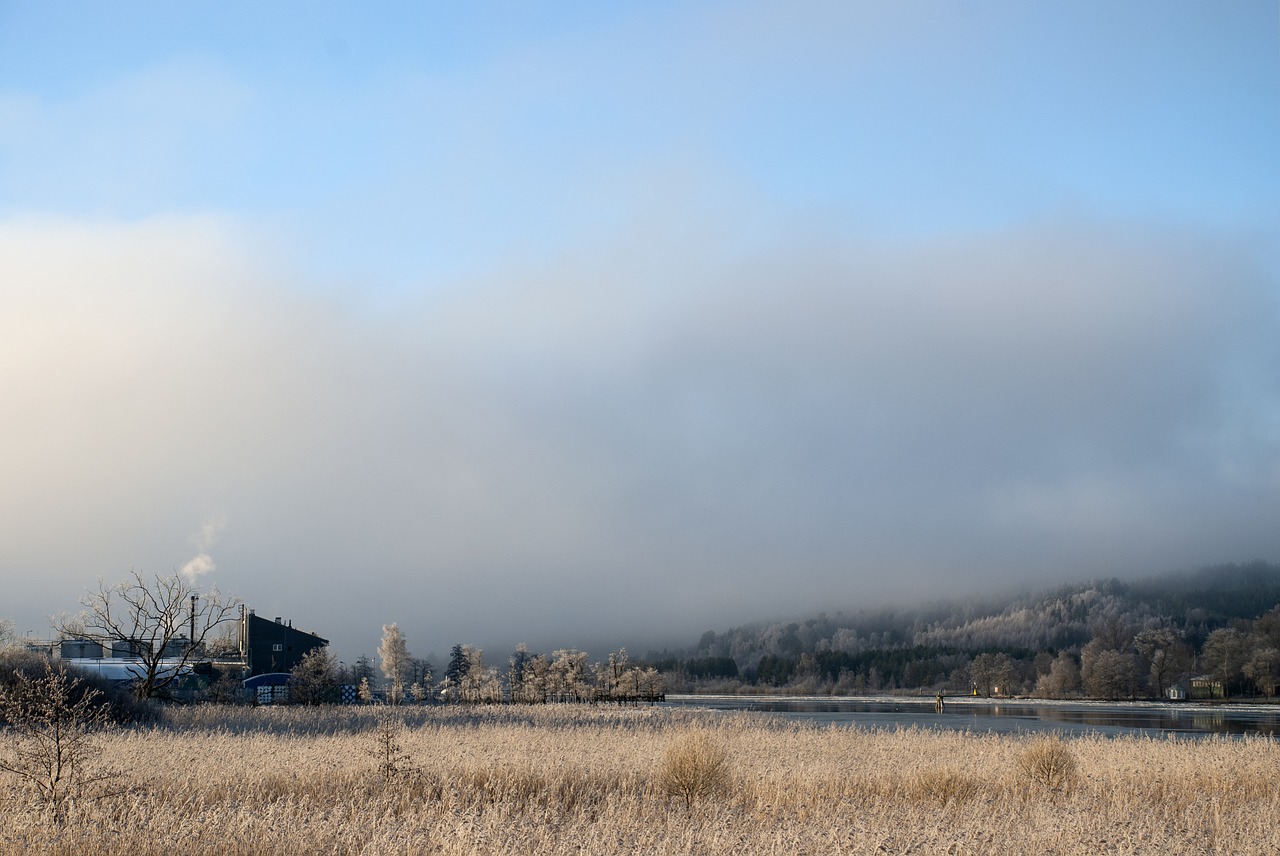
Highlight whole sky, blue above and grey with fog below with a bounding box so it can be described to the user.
[0,0,1280,662]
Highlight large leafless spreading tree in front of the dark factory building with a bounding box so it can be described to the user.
[51,571,241,699]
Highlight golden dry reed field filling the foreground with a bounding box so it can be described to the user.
[0,705,1280,856]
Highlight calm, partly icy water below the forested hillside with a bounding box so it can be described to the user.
[666,696,1280,736]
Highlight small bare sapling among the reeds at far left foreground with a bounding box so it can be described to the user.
[0,663,115,819]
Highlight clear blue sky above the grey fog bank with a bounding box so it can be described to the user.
[0,3,1280,280]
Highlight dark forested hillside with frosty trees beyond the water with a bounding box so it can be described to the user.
[649,562,1280,699]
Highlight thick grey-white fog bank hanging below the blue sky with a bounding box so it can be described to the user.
[0,218,1280,655]
